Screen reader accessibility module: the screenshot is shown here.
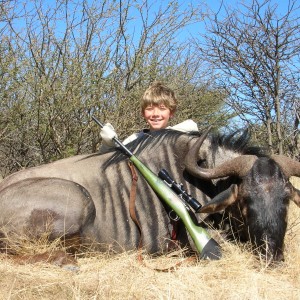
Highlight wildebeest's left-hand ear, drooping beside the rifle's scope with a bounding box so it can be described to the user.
[199,184,238,213]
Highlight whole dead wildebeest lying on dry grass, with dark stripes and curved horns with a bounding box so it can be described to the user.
[0,130,300,260]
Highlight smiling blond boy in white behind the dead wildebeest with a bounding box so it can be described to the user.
[100,82,198,152]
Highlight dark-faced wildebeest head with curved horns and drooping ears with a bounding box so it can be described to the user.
[185,127,300,261]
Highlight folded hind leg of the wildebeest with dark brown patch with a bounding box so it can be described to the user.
[0,178,95,262]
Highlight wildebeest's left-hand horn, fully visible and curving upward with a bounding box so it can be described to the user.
[185,127,257,179]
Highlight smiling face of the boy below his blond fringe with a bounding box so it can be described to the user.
[143,104,173,131]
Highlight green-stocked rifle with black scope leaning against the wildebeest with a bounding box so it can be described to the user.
[92,116,222,260]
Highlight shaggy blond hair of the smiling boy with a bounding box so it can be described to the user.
[141,81,177,112]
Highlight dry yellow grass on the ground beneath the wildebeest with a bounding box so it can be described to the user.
[0,177,300,300]
